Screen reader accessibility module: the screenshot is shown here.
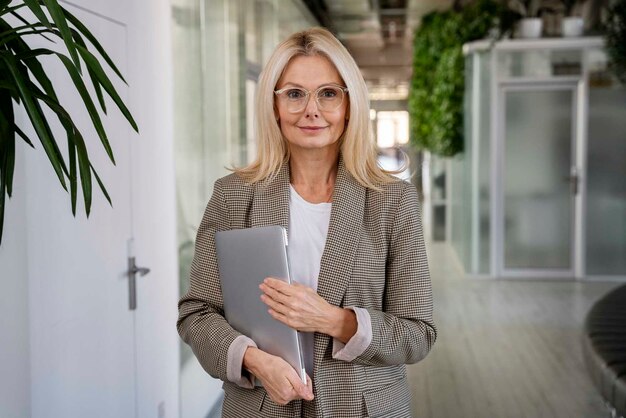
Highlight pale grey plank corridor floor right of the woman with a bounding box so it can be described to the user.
[408,244,620,418]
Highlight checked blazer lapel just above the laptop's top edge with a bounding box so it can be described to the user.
[250,162,289,229]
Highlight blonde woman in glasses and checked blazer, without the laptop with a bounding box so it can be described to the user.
[178,28,436,418]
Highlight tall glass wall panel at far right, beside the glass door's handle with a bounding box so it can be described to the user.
[586,50,626,276]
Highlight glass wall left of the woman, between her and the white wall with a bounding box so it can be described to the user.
[170,0,317,418]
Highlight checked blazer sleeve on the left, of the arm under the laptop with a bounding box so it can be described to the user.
[176,180,242,381]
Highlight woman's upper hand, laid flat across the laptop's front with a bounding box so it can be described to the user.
[259,277,357,343]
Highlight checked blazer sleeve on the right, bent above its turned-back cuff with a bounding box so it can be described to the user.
[353,183,437,366]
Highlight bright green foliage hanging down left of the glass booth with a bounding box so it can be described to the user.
[409,0,512,156]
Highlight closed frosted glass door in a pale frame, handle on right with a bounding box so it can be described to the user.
[499,84,578,278]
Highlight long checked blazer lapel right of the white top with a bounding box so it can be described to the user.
[317,157,366,306]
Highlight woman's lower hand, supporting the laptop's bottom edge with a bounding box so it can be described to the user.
[243,347,313,405]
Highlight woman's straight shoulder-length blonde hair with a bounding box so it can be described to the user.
[234,27,399,190]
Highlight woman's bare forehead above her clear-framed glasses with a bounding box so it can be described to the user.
[278,55,342,88]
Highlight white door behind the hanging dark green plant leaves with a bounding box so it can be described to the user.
[28,4,136,418]
